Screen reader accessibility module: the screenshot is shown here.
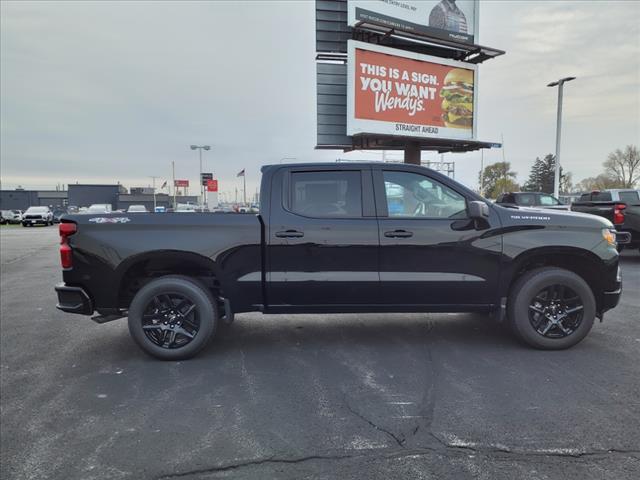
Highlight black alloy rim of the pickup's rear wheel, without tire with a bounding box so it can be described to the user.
[142,293,200,349]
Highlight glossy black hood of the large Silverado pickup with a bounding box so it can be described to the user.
[497,205,613,228]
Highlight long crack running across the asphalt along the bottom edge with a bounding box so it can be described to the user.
[156,444,640,480]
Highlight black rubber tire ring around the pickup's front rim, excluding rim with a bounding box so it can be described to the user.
[509,268,596,350]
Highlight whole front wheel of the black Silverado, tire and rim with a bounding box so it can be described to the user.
[507,267,596,350]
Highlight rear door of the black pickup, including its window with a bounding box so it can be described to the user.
[266,166,380,311]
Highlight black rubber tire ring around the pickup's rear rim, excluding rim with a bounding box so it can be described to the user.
[128,276,218,360]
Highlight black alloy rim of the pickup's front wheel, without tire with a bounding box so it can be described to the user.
[529,284,584,339]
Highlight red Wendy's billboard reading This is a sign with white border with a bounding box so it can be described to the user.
[347,40,477,140]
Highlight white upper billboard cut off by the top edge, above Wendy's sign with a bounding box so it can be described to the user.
[347,0,479,44]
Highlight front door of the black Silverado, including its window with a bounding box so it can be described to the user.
[373,167,502,309]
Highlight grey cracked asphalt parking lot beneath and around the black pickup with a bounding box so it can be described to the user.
[0,227,640,480]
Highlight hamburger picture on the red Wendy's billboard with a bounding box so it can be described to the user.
[440,68,473,129]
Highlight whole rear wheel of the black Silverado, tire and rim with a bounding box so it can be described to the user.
[128,275,219,360]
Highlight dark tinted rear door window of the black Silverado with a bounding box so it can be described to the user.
[290,171,362,217]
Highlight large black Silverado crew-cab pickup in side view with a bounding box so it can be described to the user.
[56,163,622,359]
